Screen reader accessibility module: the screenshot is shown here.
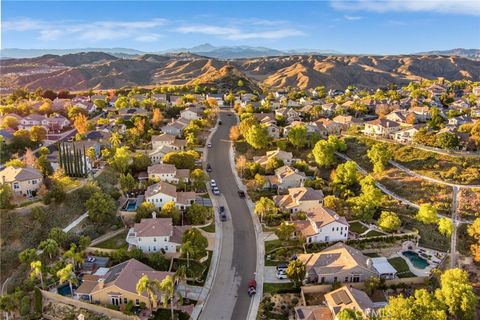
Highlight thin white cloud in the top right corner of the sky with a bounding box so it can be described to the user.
[330,0,480,15]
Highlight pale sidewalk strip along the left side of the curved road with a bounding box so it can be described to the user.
[190,121,223,320]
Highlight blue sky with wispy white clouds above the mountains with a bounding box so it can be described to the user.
[1,0,480,54]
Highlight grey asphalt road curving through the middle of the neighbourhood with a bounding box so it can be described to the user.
[200,111,257,320]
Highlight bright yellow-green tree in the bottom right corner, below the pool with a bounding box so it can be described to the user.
[435,269,478,320]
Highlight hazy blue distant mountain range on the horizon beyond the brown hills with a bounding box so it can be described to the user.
[6,43,480,60]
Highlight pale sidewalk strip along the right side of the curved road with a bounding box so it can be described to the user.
[229,113,265,320]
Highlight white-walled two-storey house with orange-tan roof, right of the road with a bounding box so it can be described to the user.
[295,206,349,243]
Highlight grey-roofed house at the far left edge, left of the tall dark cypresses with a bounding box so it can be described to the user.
[0,166,43,197]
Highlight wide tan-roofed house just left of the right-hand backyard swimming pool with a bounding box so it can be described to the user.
[298,242,378,283]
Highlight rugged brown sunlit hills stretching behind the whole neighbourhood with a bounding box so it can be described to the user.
[0,52,480,93]
